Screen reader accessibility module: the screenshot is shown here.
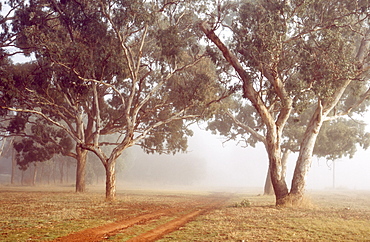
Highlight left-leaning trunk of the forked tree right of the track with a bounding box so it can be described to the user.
[200,22,292,205]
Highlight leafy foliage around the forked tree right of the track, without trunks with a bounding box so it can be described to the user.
[207,0,369,163]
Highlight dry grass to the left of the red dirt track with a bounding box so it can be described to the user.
[0,186,212,241]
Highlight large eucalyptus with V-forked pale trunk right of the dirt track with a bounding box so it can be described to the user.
[201,0,370,205]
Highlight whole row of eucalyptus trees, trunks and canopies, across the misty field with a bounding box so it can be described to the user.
[0,0,370,205]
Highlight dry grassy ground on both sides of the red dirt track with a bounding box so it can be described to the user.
[0,187,370,241]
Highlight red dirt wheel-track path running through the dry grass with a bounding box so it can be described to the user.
[54,194,231,242]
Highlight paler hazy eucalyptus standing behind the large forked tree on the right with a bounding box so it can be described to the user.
[207,93,369,195]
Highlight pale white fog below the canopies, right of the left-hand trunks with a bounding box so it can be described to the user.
[118,123,370,193]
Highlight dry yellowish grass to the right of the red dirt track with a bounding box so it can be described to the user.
[160,191,370,241]
